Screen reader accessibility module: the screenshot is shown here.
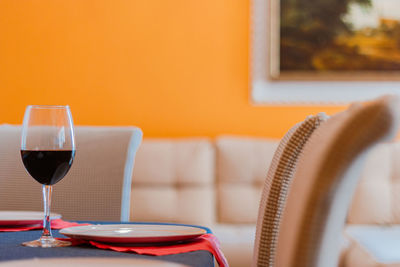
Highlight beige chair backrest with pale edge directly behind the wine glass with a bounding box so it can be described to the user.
[0,125,142,221]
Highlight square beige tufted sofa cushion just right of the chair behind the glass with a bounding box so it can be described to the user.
[131,138,215,225]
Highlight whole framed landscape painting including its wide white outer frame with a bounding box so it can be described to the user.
[249,0,400,105]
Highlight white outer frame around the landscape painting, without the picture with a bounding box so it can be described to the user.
[249,0,400,106]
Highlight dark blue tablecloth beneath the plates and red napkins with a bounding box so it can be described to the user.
[0,222,214,267]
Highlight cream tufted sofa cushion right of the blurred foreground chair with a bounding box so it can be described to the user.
[348,142,400,224]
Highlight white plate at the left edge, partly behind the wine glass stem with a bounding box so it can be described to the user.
[0,211,61,226]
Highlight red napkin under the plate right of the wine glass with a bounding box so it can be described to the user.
[58,234,229,267]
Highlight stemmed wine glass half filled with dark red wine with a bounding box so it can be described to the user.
[21,105,75,248]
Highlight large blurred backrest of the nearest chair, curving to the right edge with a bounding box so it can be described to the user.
[275,96,400,267]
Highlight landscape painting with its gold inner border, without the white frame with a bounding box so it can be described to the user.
[270,0,400,80]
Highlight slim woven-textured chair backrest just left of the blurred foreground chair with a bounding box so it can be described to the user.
[253,113,327,266]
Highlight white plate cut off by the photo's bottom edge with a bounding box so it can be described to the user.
[0,258,185,267]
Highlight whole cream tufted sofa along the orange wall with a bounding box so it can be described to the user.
[130,136,400,267]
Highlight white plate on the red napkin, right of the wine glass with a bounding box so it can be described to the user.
[60,224,207,244]
